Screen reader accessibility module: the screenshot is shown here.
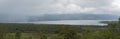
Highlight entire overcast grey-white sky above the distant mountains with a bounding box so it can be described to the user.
[0,0,120,22]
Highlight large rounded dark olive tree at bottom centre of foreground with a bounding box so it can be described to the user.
[58,26,79,39]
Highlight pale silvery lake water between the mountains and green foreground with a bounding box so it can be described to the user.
[28,20,113,25]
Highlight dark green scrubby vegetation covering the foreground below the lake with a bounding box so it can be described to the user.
[0,18,120,39]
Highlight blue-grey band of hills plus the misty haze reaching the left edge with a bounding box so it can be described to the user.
[0,13,119,23]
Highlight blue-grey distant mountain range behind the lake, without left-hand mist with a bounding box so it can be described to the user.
[28,14,119,21]
